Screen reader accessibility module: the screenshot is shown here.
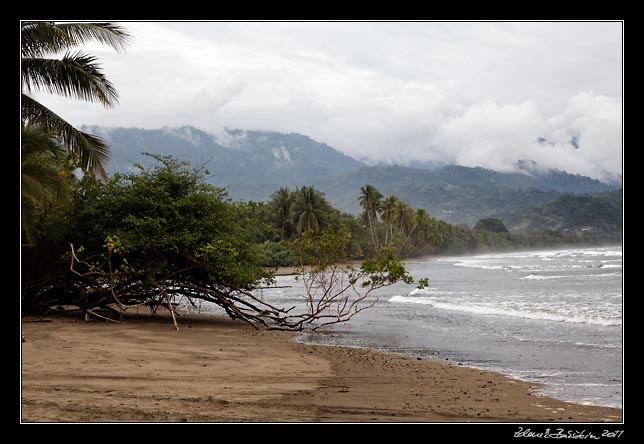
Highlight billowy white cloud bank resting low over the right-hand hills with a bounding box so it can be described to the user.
[418,92,622,181]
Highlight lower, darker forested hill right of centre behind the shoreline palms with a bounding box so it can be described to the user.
[317,165,612,226]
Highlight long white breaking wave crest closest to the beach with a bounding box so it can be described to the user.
[389,295,622,326]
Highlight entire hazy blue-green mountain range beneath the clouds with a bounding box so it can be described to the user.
[82,126,621,228]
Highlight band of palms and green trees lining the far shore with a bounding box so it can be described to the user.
[243,176,621,266]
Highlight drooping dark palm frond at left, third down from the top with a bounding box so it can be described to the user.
[22,94,110,179]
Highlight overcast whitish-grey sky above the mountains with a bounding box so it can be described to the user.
[37,22,623,181]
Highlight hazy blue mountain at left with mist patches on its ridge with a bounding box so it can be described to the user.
[89,126,364,185]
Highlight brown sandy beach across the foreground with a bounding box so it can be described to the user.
[21,316,622,423]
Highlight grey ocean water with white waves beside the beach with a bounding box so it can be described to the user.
[182,245,624,408]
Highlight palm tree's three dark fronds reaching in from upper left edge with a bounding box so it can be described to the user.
[21,22,130,178]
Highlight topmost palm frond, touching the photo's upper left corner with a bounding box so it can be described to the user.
[20,22,132,57]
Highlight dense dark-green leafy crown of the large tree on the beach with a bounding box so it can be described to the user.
[23,156,269,322]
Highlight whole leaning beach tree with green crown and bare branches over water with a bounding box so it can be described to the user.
[23,156,426,330]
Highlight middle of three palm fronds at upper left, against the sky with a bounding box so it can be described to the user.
[22,52,118,106]
